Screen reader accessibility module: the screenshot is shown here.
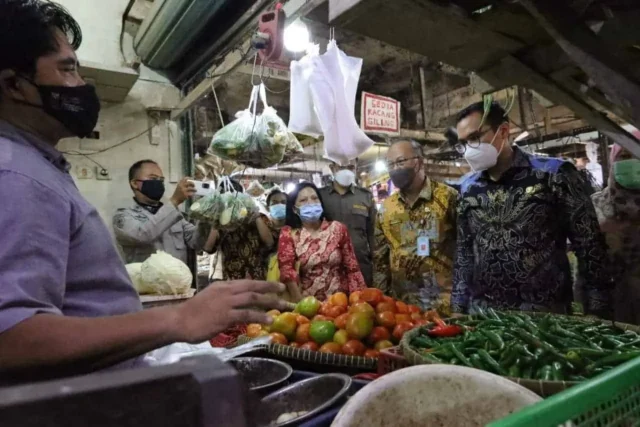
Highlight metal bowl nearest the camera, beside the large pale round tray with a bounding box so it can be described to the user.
[259,374,351,427]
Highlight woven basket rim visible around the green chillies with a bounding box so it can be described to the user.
[400,311,640,397]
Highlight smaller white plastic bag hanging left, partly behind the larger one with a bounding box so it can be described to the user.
[289,45,322,138]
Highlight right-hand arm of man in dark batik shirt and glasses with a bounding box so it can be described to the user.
[551,163,614,318]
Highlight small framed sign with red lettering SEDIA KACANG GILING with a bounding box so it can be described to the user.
[360,92,400,135]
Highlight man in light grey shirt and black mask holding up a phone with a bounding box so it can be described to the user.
[113,160,211,264]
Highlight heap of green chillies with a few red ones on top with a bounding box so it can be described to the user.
[409,309,640,381]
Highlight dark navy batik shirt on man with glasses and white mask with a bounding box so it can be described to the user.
[452,147,612,313]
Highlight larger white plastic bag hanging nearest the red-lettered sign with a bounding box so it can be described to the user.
[309,40,374,164]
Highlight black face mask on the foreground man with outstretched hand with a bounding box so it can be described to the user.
[18,78,100,138]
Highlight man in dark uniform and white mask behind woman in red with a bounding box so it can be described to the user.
[320,162,376,286]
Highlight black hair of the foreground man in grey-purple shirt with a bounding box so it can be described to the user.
[0,0,82,76]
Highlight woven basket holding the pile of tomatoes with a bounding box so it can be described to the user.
[238,335,378,371]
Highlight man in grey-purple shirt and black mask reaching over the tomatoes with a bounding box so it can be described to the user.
[0,0,284,382]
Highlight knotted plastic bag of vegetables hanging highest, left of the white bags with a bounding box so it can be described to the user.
[210,84,302,168]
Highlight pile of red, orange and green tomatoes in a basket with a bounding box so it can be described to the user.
[247,288,433,358]
